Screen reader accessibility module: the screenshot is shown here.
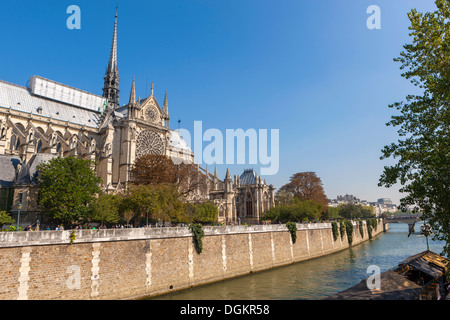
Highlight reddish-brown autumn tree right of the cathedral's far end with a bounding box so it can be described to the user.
[280,172,328,212]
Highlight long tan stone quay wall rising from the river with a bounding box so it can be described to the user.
[0,221,386,300]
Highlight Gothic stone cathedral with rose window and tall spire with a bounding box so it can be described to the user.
[0,13,274,224]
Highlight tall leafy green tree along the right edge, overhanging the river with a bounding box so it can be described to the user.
[379,0,450,254]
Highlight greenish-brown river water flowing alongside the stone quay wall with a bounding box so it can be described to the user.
[152,223,444,300]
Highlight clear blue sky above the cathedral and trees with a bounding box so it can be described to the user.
[0,0,436,204]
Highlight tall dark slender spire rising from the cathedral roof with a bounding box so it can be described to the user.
[103,6,119,109]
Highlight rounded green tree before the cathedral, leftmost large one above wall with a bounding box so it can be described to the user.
[37,156,101,225]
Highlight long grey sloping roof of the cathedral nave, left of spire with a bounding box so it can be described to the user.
[0,80,101,128]
